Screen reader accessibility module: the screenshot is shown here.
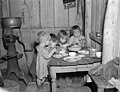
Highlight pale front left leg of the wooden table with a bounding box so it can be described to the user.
[49,67,57,92]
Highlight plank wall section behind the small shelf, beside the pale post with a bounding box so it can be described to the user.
[90,0,107,48]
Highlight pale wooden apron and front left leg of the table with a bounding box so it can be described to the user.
[49,57,100,92]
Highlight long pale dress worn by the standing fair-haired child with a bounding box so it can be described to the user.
[36,45,49,79]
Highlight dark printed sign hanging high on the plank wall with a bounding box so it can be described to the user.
[63,0,76,9]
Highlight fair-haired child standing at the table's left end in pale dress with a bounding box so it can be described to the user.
[36,32,57,89]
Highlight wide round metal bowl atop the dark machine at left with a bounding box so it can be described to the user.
[1,17,22,28]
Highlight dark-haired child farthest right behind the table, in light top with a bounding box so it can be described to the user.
[69,25,85,47]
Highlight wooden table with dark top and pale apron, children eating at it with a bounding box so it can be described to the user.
[48,58,100,92]
